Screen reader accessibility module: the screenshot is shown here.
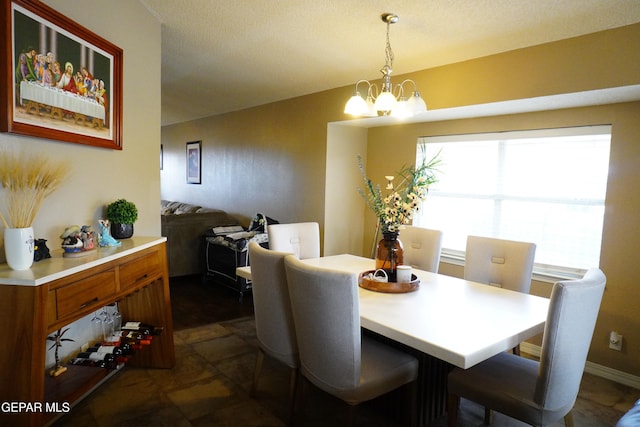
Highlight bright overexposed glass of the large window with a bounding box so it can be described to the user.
[414,126,611,272]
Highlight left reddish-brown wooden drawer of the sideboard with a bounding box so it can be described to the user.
[56,269,116,319]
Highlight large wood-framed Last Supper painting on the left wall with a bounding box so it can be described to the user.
[0,0,123,150]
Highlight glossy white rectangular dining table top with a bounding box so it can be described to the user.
[238,255,549,369]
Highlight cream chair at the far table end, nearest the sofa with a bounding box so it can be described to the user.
[267,222,320,259]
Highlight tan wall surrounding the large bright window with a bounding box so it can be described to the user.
[365,102,640,375]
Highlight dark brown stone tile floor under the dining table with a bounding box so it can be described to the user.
[54,316,640,427]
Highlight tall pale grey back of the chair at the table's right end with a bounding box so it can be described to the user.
[534,268,606,409]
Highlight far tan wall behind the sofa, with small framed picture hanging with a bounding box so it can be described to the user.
[161,91,350,231]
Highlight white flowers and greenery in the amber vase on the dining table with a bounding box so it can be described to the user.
[358,144,441,234]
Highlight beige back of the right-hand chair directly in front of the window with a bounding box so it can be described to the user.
[464,236,536,294]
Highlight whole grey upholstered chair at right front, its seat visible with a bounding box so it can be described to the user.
[448,268,606,427]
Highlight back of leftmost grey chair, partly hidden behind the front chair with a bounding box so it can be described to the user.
[249,242,299,368]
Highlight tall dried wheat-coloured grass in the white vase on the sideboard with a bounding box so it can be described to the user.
[0,151,69,228]
